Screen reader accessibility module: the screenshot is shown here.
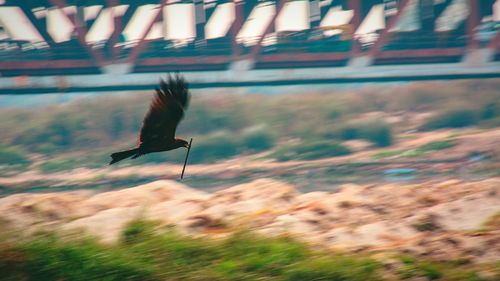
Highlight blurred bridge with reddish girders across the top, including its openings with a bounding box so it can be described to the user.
[0,0,500,94]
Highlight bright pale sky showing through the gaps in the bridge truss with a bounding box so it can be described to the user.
[0,0,500,43]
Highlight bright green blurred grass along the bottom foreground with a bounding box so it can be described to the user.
[0,220,497,281]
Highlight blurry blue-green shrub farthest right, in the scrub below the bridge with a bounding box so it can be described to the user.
[420,109,478,131]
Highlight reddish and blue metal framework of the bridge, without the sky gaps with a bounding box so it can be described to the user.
[0,0,500,94]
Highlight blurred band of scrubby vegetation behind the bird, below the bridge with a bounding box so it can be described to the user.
[0,80,500,171]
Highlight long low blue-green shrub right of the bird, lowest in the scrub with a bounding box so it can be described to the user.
[270,141,351,161]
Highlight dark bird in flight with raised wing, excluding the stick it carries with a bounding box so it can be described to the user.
[109,75,190,165]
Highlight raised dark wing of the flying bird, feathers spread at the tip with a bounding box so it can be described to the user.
[139,75,189,146]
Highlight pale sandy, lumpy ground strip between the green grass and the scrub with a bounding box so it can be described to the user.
[0,178,500,262]
